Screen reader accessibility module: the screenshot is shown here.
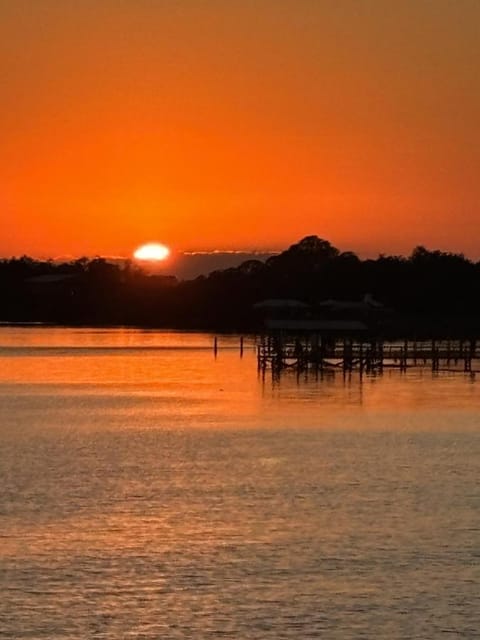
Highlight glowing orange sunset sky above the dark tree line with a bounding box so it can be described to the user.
[0,0,480,259]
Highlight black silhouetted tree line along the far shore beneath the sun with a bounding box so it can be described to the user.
[0,236,480,334]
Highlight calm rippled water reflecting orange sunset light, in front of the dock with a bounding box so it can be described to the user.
[0,328,480,640]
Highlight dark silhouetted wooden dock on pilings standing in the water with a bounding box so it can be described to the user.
[257,333,480,374]
